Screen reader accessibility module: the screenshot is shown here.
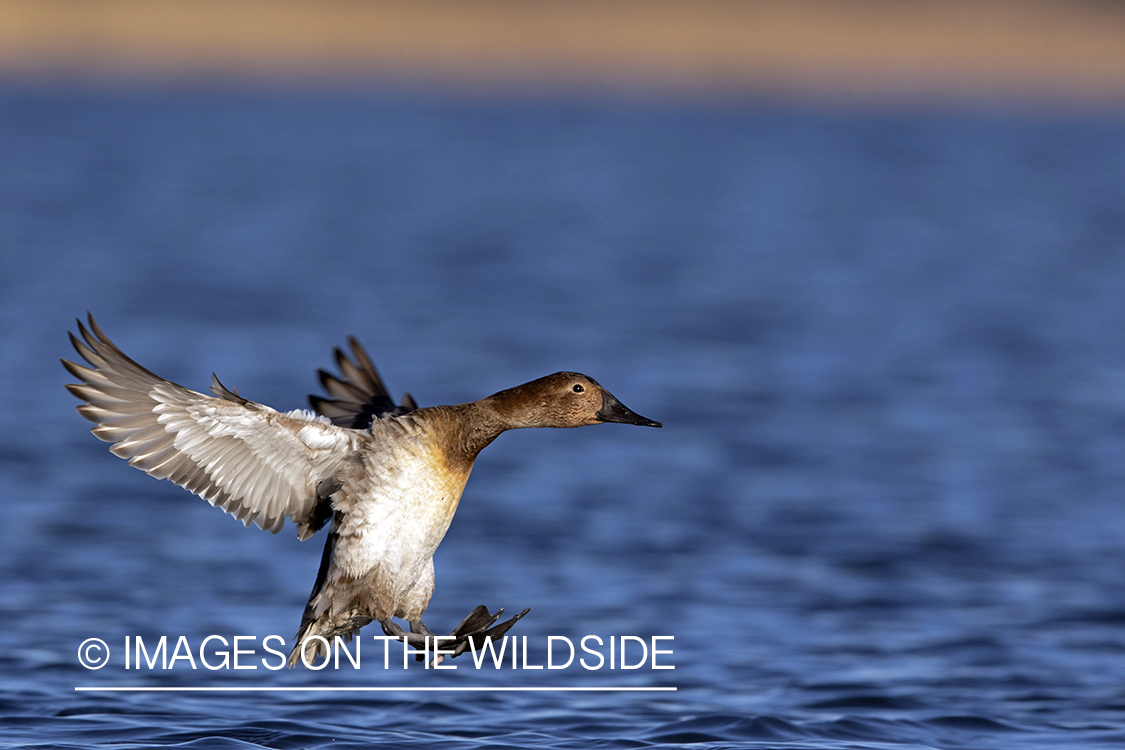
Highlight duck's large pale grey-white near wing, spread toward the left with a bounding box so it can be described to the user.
[62,315,358,539]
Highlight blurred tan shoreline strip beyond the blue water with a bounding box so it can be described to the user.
[0,0,1125,107]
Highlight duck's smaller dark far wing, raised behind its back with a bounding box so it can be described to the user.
[308,336,417,430]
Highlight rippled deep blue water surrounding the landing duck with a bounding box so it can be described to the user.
[0,88,1125,750]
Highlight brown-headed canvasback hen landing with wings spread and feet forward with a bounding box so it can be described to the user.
[62,315,660,666]
